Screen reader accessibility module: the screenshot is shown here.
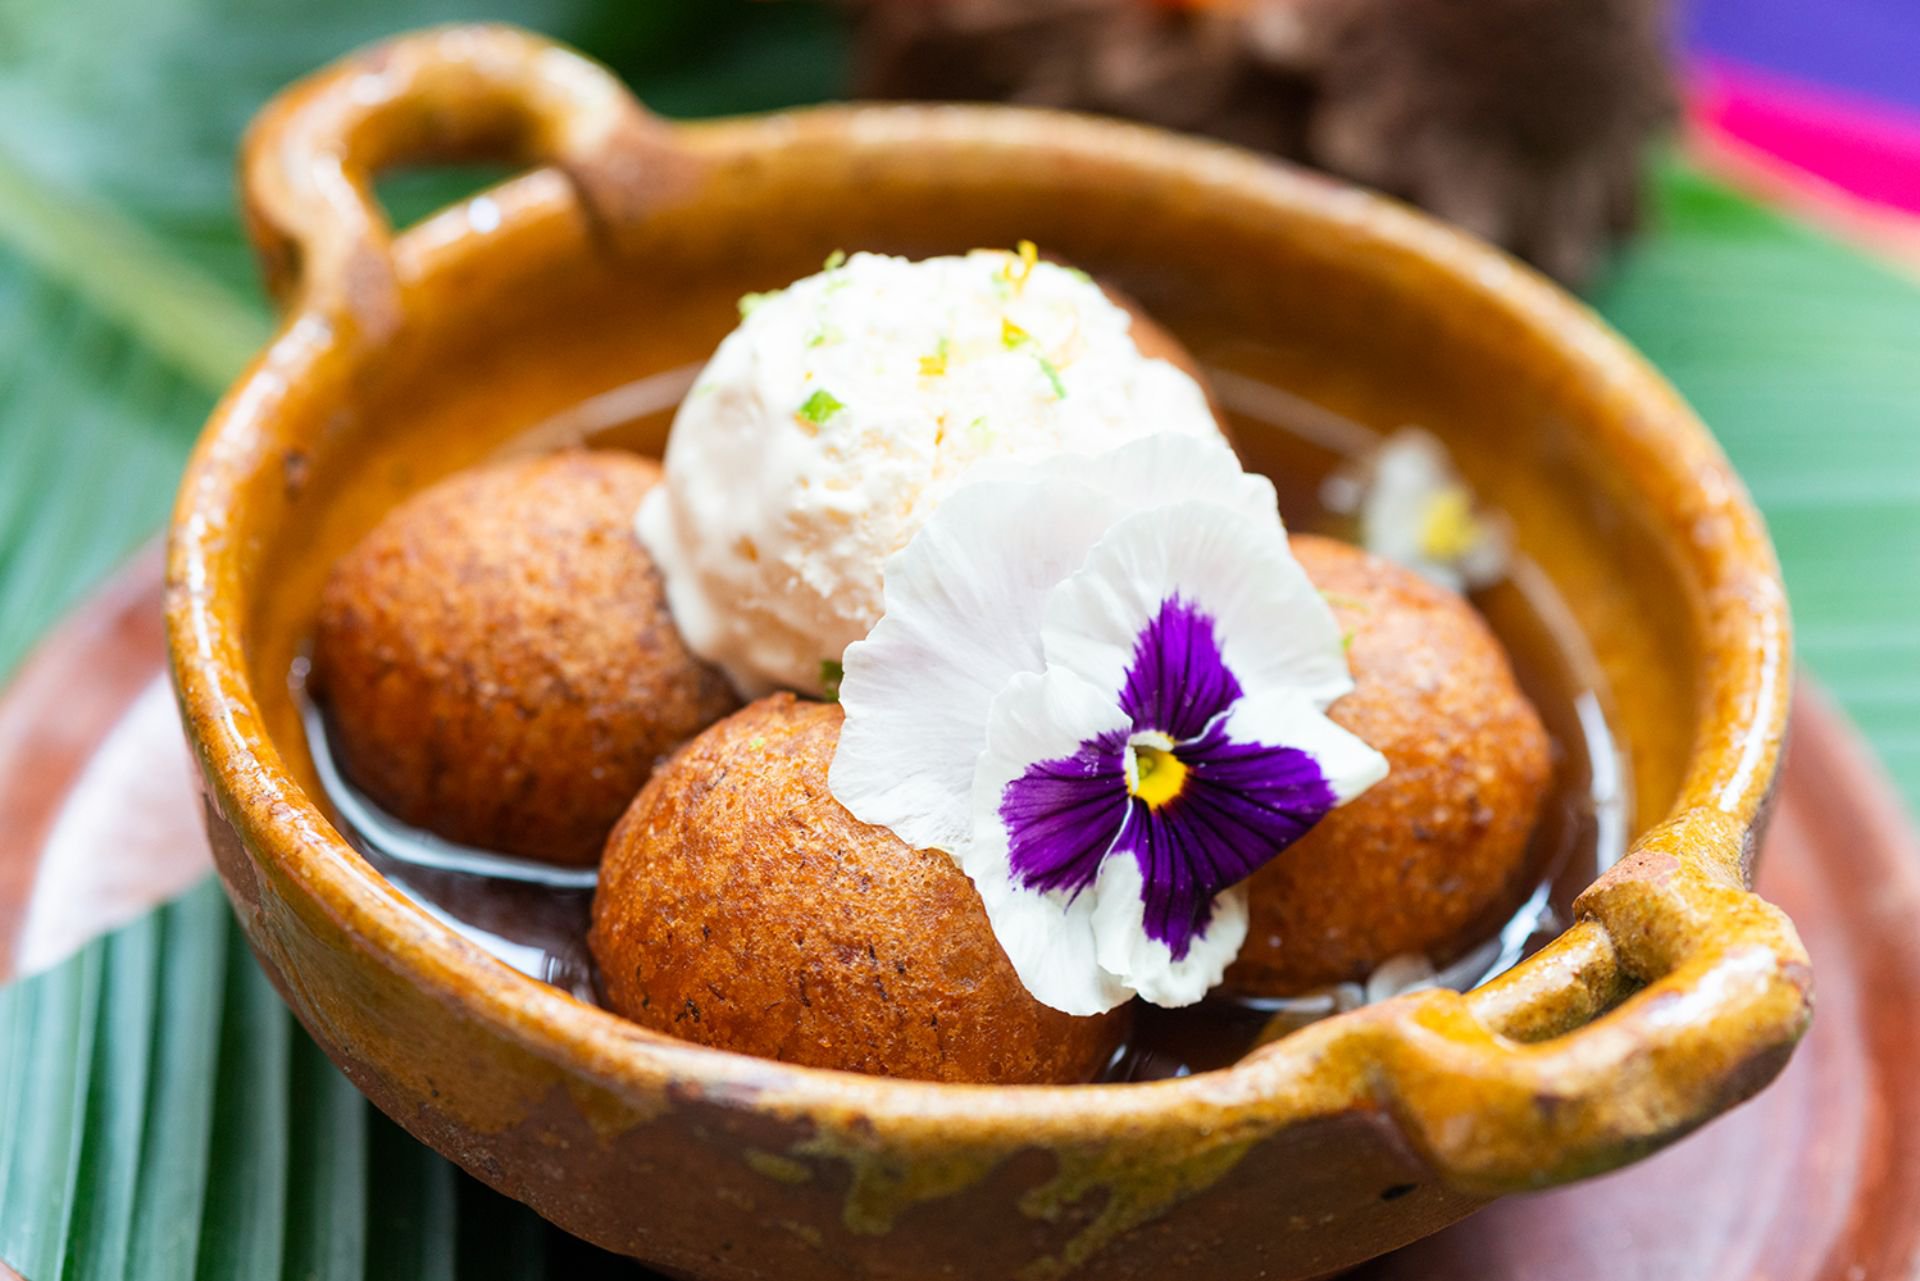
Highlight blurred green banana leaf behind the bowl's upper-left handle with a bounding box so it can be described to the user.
[0,0,845,678]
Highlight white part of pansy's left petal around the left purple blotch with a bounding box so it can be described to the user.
[960,672,1139,1014]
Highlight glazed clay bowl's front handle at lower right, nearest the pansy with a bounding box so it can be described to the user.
[1313,805,1812,1196]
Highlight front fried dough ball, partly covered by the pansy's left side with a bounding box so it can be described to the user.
[591,693,1127,1083]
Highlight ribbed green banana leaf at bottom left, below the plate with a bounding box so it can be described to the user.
[0,880,599,1281]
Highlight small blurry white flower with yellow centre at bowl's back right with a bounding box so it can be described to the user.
[1323,426,1513,592]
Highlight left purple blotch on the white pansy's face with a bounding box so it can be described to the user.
[1000,734,1131,893]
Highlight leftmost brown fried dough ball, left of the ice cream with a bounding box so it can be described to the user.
[313,449,739,866]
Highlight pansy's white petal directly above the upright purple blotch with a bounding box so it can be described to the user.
[1041,499,1354,707]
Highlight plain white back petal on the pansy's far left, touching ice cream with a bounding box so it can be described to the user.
[828,480,1116,853]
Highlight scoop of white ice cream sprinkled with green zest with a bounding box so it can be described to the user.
[637,248,1219,697]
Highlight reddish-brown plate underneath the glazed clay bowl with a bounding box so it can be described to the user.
[0,551,1920,1281]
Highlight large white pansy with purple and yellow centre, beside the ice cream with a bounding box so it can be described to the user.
[829,436,1386,1014]
